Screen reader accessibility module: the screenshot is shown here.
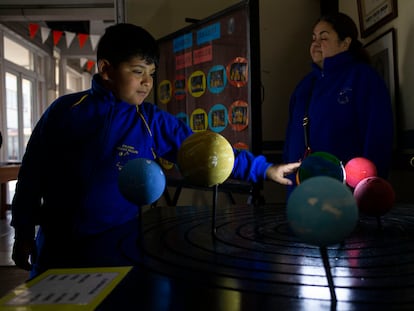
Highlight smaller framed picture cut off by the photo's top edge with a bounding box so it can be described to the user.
[357,0,398,38]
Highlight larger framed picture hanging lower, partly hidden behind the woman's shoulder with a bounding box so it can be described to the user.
[364,28,399,146]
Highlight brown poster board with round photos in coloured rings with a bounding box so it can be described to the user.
[155,0,262,180]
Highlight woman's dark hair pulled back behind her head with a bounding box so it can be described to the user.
[316,12,371,63]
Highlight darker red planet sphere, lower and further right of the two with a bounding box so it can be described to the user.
[354,176,395,217]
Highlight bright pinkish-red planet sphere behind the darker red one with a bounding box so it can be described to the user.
[345,157,377,188]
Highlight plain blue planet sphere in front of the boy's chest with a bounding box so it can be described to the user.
[118,158,166,205]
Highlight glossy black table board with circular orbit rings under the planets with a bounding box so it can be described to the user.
[117,205,414,310]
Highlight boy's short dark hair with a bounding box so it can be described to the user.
[96,23,159,67]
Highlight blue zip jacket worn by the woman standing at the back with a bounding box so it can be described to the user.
[284,51,394,194]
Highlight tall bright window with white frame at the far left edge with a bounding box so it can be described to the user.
[0,28,47,162]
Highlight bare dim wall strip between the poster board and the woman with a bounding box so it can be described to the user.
[260,0,319,141]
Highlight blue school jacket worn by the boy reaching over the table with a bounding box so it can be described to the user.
[12,75,271,239]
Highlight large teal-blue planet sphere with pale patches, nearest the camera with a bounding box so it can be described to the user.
[287,176,359,247]
